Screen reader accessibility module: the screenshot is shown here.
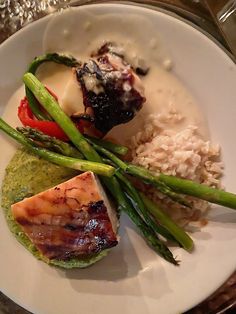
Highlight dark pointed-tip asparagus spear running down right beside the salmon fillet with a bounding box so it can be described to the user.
[106,177,179,265]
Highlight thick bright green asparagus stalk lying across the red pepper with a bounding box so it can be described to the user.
[23,73,102,162]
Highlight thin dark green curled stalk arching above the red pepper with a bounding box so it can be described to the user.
[25,53,80,120]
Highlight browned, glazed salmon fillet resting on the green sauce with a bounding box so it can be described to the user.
[11,172,118,260]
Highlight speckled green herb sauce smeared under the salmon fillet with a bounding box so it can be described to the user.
[1,149,107,268]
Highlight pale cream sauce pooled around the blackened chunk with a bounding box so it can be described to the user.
[4,9,208,143]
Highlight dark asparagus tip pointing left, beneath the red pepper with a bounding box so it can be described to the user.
[16,127,83,159]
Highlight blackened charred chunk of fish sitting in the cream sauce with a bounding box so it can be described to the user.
[76,42,146,134]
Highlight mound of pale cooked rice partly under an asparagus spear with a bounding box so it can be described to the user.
[131,109,223,225]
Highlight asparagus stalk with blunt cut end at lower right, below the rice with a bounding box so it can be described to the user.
[140,193,194,251]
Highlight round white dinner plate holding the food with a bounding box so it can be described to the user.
[0,4,236,314]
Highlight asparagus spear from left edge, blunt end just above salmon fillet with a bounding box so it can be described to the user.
[0,118,115,176]
